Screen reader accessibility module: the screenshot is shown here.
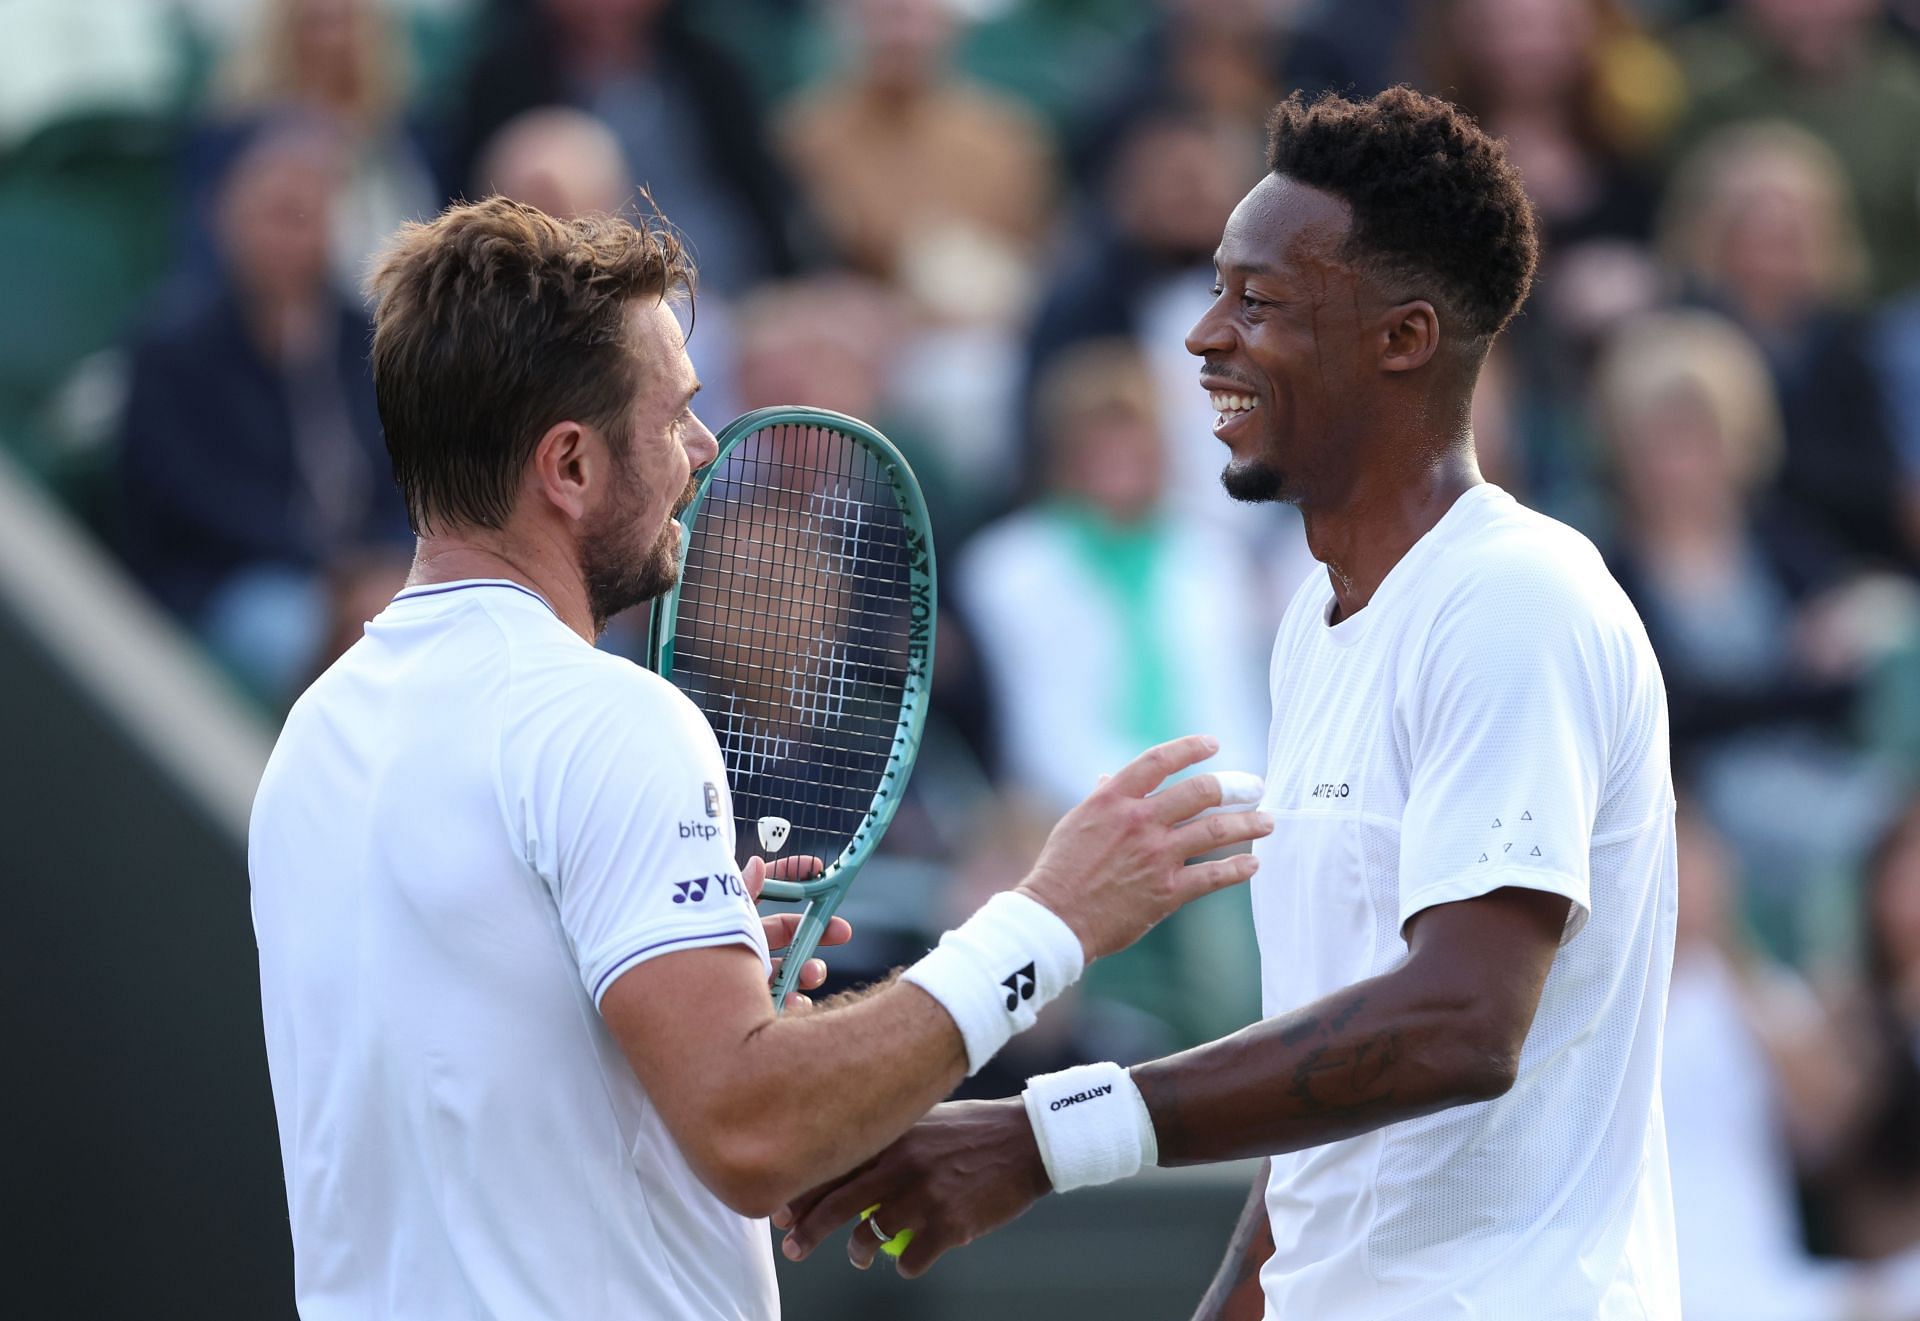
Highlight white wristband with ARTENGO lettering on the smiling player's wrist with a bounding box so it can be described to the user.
[1021,1064,1160,1192]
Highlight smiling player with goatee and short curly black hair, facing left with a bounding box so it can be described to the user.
[778,88,1680,1321]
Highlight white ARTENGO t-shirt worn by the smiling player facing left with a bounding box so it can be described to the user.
[1252,486,1680,1321]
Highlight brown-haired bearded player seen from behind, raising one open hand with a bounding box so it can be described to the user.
[250,200,1273,1321]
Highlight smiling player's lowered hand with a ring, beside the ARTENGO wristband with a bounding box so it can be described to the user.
[774,1098,1050,1279]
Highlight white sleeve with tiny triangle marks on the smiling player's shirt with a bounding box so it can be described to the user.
[1400,568,1615,945]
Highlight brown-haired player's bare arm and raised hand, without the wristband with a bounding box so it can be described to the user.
[601,739,1271,1215]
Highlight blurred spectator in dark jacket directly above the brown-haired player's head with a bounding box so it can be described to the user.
[451,0,795,296]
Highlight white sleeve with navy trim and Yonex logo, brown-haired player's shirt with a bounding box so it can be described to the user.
[503,662,770,1006]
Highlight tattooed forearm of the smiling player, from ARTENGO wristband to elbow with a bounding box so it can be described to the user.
[1133,966,1511,1165]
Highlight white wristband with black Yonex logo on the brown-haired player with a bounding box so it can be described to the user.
[900,891,1087,1075]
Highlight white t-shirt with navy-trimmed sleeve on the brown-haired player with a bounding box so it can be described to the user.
[248,580,780,1321]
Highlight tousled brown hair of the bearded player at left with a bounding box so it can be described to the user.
[371,198,693,536]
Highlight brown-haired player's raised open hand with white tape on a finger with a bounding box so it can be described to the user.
[1020,735,1273,962]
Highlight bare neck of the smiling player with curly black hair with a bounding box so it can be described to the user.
[1300,445,1484,622]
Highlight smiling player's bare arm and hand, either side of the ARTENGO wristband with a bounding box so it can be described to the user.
[783,889,1569,1275]
